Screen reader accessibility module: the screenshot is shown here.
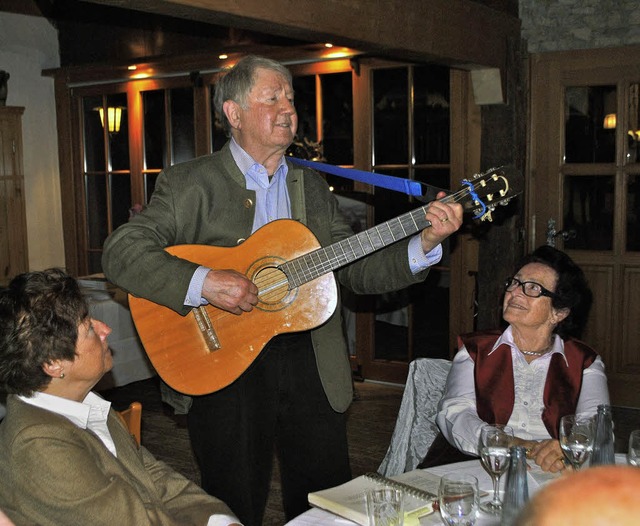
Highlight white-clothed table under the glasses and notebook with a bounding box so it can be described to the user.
[286,453,626,526]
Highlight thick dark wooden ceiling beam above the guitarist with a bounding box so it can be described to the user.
[80,0,520,69]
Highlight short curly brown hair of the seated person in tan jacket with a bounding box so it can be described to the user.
[0,269,89,396]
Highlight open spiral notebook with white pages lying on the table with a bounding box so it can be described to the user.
[308,469,440,526]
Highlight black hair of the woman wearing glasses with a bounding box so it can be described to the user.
[517,245,593,338]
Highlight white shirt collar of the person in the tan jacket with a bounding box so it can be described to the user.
[18,392,111,429]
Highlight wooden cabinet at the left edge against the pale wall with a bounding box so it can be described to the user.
[0,106,29,286]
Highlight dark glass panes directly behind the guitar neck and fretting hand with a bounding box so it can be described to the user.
[372,65,450,362]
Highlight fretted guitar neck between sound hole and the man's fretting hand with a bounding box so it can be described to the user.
[279,205,432,288]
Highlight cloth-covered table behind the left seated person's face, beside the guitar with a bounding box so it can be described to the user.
[78,276,156,391]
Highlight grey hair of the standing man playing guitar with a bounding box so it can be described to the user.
[213,55,292,137]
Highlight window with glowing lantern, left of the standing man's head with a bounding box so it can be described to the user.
[76,79,200,274]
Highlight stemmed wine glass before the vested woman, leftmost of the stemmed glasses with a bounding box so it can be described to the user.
[479,424,513,515]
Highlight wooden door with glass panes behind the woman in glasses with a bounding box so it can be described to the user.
[527,47,640,407]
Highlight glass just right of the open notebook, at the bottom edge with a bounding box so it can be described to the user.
[438,473,479,526]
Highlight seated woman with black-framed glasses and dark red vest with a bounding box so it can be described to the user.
[421,246,609,472]
